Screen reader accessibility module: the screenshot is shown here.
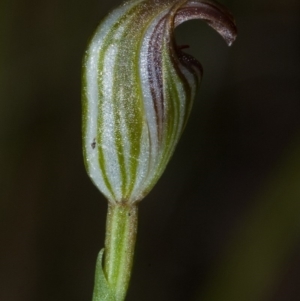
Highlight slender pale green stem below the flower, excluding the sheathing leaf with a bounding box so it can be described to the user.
[104,204,138,301]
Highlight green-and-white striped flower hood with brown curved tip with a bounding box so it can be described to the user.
[82,0,236,203]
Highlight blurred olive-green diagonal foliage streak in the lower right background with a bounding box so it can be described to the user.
[199,134,300,301]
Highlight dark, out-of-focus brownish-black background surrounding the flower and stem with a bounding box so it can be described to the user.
[0,0,300,301]
